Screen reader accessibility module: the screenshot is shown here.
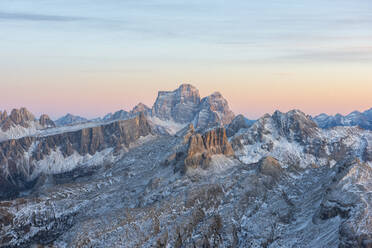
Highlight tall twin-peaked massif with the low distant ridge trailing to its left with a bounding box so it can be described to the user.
[56,84,235,131]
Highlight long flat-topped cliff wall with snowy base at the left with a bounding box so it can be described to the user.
[0,114,151,201]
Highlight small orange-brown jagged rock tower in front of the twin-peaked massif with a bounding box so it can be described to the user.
[185,128,234,170]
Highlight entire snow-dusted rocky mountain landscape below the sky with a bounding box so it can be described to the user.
[0,84,372,248]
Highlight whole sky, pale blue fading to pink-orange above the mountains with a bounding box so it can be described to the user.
[0,0,372,119]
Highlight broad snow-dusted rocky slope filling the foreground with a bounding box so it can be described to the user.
[0,123,372,248]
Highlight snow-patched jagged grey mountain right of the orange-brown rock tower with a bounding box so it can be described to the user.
[231,110,372,167]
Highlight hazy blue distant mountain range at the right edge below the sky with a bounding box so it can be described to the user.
[314,109,372,130]
